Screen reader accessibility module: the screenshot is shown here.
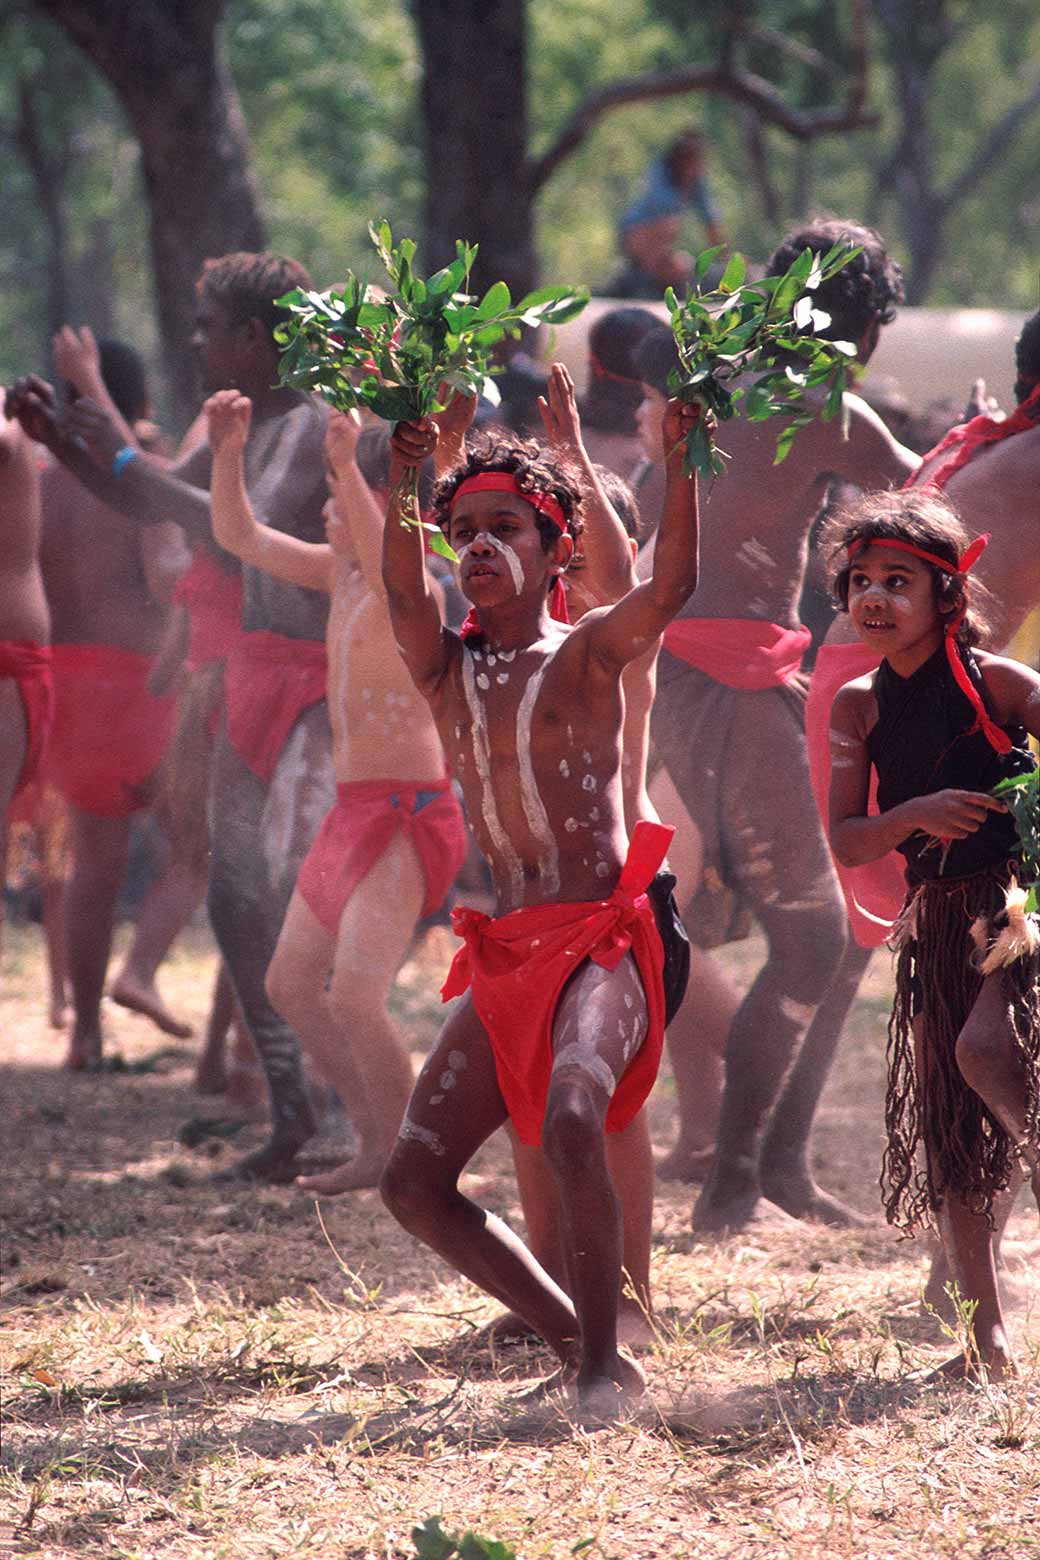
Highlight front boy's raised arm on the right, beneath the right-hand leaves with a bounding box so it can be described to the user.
[574,401,700,666]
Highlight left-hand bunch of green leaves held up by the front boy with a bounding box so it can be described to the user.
[276,222,588,557]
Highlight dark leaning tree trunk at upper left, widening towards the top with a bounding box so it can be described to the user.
[36,0,265,423]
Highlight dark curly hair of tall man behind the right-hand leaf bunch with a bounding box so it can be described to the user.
[766,218,906,342]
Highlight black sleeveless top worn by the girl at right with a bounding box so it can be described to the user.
[867,644,1035,878]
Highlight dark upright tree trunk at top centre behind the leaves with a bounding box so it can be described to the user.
[412,0,538,296]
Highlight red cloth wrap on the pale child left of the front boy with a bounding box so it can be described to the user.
[296,777,468,934]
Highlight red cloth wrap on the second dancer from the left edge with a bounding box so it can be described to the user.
[45,644,175,817]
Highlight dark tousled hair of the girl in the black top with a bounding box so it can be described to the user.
[820,487,989,644]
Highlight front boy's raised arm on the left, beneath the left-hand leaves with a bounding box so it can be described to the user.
[382,418,458,696]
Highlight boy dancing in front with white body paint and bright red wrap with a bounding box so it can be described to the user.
[375,402,697,1421]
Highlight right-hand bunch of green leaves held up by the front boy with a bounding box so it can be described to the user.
[664,243,859,477]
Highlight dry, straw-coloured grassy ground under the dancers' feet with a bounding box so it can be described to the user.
[0,928,1040,1560]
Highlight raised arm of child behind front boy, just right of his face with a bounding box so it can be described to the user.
[538,363,636,604]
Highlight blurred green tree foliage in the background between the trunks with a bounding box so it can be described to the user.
[0,0,1040,402]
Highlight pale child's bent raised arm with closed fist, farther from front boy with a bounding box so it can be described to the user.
[206,390,332,591]
